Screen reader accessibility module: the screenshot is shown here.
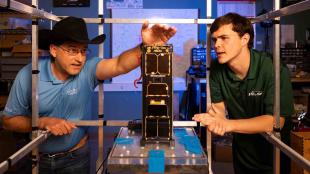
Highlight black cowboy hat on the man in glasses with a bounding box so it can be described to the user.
[39,16,105,50]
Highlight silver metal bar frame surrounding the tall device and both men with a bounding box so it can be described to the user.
[0,0,310,174]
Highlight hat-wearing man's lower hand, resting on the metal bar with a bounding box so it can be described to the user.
[39,117,77,136]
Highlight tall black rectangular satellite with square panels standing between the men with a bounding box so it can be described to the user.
[141,45,174,146]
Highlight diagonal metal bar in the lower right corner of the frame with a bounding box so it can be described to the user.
[262,133,310,171]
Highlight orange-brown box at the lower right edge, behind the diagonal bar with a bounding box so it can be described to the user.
[291,132,310,174]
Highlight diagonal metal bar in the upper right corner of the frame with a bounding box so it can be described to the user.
[252,0,310,23]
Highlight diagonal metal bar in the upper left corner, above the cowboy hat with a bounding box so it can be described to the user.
[0,0,60,21]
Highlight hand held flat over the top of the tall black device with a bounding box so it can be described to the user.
[141,21,177,45]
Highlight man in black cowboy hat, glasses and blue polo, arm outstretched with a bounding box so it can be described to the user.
[3,17,176,173]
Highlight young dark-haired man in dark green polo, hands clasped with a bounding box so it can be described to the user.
[193,13,293,174]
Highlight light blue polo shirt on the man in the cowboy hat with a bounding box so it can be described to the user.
[3,57,101,153]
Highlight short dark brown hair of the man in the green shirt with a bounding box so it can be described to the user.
[210,13,254,49]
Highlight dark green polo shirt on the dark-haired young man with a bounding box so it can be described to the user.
[210,50,294,174]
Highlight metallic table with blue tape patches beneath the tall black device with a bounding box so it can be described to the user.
[107,127,208,174]
